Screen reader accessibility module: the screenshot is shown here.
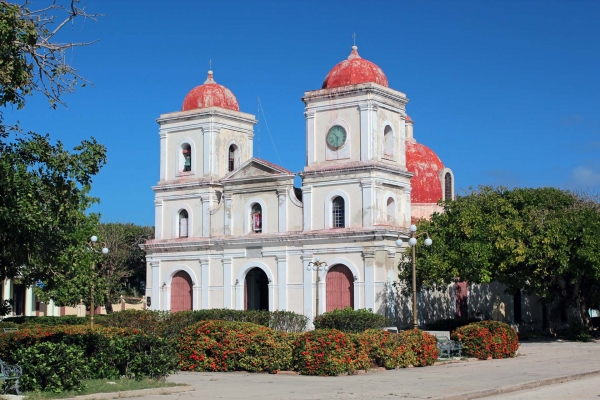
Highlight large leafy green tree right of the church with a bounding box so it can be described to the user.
[400,186,600,326]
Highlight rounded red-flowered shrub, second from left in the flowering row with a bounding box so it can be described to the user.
[294,329,371,376]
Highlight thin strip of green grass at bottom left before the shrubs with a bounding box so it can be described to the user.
[25,379,181,400]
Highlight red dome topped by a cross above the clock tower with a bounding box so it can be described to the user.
[322,46,388,89]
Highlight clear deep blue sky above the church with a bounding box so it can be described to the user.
[5,0,600,224]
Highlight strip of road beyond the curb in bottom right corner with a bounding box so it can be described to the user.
[486,377,600,400]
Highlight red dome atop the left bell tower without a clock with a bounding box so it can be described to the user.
[181,71,240,111]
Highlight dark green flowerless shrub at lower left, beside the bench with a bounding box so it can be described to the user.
[15,342,88,393]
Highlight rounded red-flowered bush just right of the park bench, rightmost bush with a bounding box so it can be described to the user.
[452,321,519,360]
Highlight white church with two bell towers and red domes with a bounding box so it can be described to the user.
[144,46,457,324]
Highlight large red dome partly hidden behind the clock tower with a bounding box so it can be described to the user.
[406,141,444,203]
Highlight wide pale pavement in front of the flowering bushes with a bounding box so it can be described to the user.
[147,342,600,400]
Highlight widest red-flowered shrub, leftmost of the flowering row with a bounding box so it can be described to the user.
[177,321,293,373]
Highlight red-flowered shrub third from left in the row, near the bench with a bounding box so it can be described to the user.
[358,329,415,369]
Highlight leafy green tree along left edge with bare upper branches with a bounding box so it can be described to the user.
[0,1,106,284]
